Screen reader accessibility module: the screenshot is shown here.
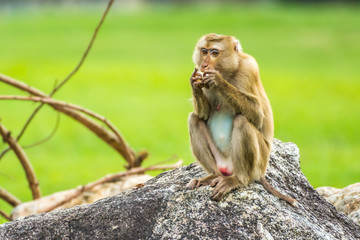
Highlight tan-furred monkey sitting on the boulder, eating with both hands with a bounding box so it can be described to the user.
[187,33,297,206]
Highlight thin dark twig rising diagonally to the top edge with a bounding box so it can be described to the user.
[0,0,114,159]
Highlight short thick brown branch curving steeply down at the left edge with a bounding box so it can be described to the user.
[0,123,40,199]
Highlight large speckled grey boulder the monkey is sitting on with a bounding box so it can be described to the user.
[0,140,360,240]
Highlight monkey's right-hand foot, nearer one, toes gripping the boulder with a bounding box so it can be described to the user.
[210,176,241,201]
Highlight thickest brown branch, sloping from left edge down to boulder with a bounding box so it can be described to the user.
[0,74,137,167]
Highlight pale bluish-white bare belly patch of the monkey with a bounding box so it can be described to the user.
[208,110,234,152]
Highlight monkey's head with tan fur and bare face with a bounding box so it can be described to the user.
[193,34,239,73]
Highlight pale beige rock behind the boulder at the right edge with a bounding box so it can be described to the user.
[316,182,360,225]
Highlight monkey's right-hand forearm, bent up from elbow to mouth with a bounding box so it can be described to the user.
[204,70,264,130]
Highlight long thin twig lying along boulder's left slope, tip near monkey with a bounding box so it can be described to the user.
[42,160,183,213]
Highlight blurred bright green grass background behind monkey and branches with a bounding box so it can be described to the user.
[0,2,360,223]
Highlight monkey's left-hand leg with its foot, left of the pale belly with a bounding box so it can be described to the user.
[187,113,221,189]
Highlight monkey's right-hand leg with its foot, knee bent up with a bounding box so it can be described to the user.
[211,115,261,201]
